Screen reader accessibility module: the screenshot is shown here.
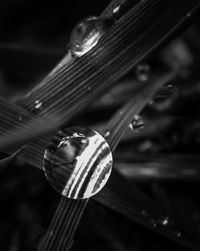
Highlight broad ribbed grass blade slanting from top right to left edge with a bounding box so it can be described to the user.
[0,0,198,157]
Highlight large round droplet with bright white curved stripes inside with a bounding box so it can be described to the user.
[43,127,112,199]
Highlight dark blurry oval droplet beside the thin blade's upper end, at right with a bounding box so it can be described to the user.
[151,84,177,111]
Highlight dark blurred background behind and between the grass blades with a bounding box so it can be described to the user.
[0,0,200,251]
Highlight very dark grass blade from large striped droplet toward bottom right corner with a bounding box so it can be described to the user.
[95,172,195,248]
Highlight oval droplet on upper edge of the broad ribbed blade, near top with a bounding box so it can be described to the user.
[70,16,113,57]
